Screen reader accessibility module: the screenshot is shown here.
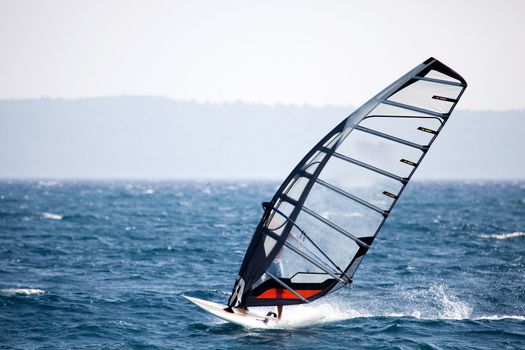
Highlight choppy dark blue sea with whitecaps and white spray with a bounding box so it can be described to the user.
[0,181,525,349]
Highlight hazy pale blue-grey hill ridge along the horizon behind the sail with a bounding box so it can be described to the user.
[0,96,525,179]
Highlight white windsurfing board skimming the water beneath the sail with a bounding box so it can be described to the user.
[183,295,280,328]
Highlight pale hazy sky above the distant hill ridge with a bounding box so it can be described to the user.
[0,0,525,110]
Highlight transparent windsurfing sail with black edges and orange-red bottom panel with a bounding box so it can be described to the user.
[228,57,467,308]
